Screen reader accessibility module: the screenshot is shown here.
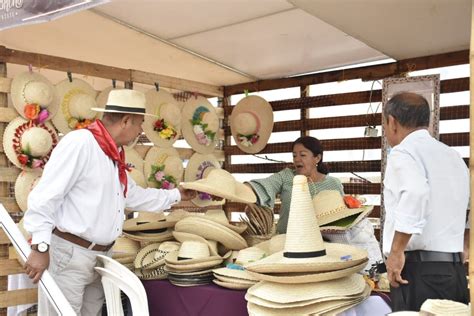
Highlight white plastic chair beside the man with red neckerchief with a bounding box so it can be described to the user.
[95,267,149,316]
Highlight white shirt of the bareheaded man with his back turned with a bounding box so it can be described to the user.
[383,129,470,256]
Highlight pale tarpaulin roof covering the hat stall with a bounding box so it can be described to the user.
[0,0,471,86]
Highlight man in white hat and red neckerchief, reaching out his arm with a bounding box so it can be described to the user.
[24,89,195,315]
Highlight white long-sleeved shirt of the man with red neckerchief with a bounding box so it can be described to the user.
[24,130,181,245]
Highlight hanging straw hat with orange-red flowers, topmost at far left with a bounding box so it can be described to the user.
[10,71,59,123]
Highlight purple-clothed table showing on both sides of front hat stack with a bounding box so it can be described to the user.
[143,280,391,316]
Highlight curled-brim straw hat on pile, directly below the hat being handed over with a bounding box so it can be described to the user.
[175,216,247,250]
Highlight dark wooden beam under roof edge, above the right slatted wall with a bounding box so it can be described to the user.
[224,50,469,96]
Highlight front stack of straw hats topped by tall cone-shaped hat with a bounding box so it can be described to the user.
[245,175,370,315]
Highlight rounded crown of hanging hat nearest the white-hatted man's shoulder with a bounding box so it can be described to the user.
[21,126,53,157]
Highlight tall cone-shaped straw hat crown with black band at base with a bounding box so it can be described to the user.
[284,175,325,257]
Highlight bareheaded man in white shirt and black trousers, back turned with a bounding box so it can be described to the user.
[383,92,470,311]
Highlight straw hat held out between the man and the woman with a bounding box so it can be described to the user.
[181,168,257,203]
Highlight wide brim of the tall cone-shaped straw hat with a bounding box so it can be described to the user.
[245,243,367,273]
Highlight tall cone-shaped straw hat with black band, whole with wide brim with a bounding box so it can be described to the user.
[245,175,367,273]
